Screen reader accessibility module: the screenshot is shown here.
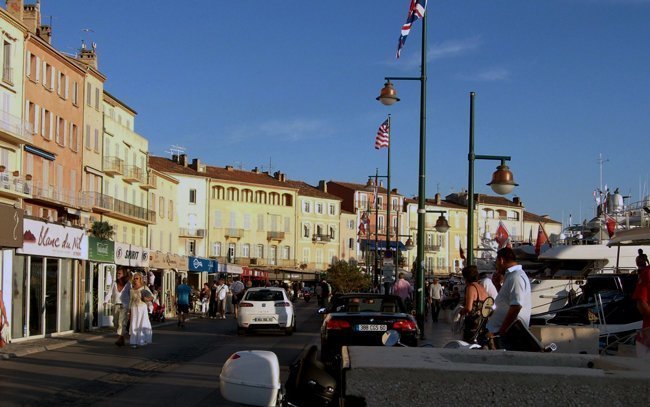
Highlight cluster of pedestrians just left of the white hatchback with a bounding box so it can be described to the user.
[199,276,246,319]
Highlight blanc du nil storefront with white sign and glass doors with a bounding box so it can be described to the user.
[10,219,88,340]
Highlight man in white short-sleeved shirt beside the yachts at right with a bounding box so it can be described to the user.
[487,247,532,346]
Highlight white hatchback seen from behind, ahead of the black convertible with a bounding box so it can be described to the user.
[237,287,296,335]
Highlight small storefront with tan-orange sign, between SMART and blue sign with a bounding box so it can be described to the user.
[149,251,187,317]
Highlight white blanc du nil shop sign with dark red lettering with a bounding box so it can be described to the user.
[17,219,88,260]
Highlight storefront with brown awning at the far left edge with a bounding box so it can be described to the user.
[0,203,23,340]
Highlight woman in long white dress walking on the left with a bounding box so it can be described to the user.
[129,273,153,348]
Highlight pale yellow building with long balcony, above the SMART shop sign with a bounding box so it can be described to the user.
[100,91,156,247]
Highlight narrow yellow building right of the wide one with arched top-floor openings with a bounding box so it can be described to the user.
[287,181,341,273]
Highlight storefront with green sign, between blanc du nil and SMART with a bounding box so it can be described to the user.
[82,236,116,329]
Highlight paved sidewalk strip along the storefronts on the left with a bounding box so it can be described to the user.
[0,319,176,359]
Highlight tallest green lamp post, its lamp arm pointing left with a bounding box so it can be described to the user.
[377,13,429,338]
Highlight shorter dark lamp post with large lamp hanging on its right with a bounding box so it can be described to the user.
[467,92,519,266]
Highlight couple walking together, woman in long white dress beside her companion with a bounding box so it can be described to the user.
[104,267,154,348]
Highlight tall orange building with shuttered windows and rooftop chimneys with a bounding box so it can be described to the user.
[23,5,85,224]
